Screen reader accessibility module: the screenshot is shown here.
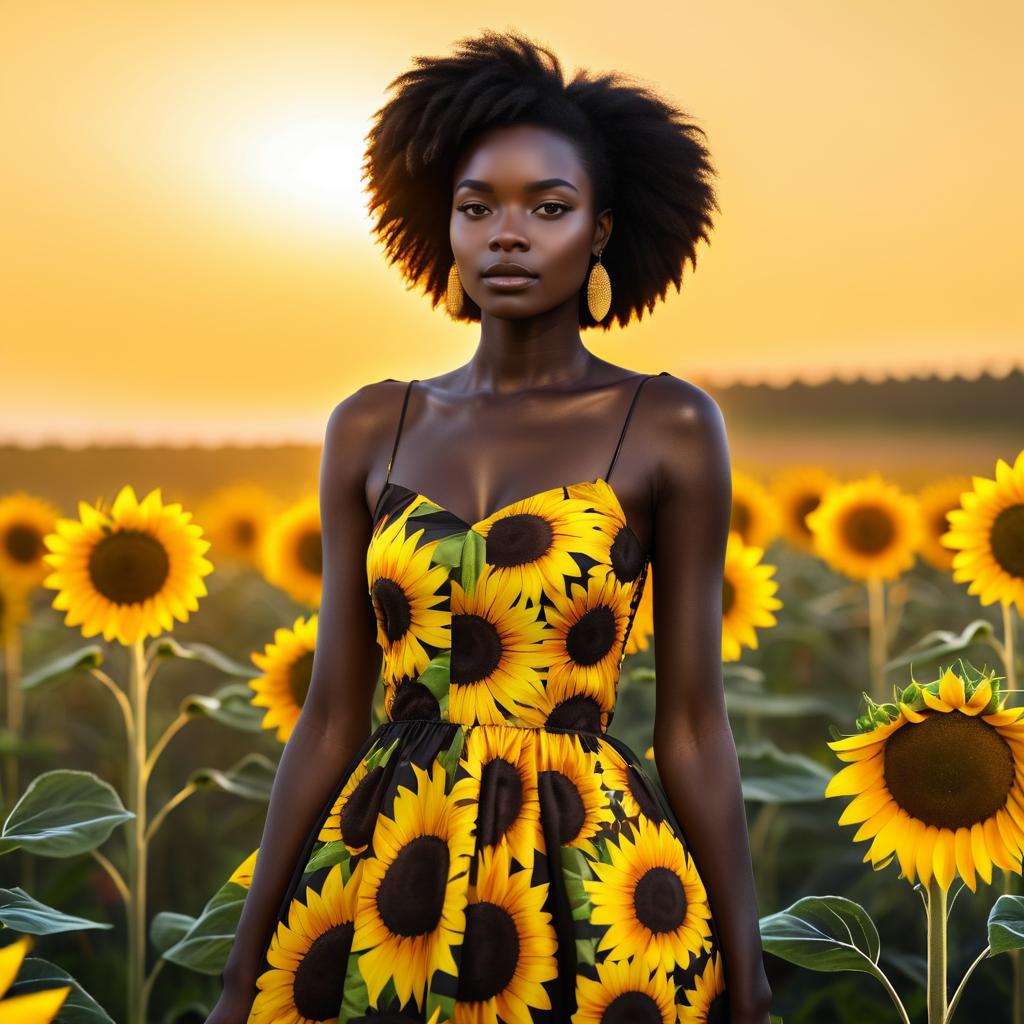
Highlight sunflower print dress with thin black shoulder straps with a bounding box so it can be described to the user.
[249,377,728,1024]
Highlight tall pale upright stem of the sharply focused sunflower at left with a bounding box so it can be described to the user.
[128,639,150,1024]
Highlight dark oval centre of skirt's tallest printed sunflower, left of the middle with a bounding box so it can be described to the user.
[377,836,449,936]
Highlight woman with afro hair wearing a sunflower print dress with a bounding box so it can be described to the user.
[208,33,770,1024]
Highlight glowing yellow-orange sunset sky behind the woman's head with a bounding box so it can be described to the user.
[0,0,1024,443]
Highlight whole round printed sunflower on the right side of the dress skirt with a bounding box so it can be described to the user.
[583,817,712,972]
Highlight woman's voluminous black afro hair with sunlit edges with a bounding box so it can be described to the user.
[362,31,719,329]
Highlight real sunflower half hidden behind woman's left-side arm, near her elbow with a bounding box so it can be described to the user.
[249,611,317,743]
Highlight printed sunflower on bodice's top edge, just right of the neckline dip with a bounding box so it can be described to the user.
[472,487,608,605]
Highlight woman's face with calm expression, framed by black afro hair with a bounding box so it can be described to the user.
[450,125,611,319]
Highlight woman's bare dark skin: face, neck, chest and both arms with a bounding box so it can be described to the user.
[218,124,770,1024]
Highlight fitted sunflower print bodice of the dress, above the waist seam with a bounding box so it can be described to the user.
[367,477,649,733]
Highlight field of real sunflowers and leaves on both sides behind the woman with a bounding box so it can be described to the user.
[0,450,1024,1024]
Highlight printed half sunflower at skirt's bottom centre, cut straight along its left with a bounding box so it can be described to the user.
[455,846,558,1024]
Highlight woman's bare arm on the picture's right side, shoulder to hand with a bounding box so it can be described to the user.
[645,378,771,1024]
